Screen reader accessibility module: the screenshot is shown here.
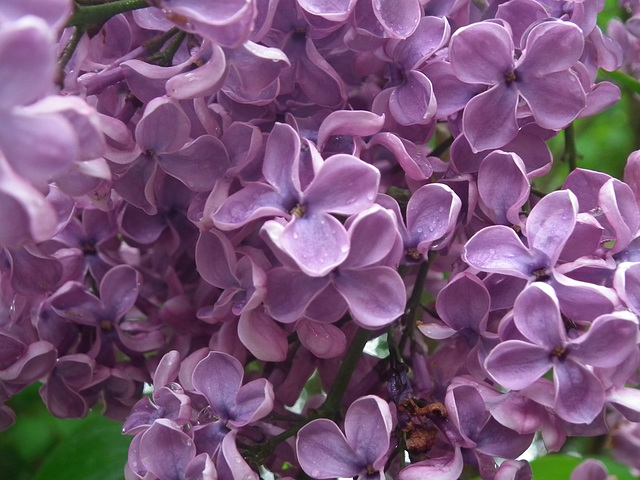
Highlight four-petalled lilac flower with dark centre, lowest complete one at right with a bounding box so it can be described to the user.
[485,283,638,423]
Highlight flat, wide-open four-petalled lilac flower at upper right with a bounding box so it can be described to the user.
[449,21,586,152]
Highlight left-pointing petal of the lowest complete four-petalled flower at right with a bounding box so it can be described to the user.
[485,340,553,390]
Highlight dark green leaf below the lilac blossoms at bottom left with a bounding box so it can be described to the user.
[33,412,132,480]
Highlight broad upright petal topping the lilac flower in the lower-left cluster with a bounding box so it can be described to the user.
[192,352,244,420]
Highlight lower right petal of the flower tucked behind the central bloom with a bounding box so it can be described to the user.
[333,267,406,329]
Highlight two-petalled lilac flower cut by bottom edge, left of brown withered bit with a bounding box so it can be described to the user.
[296,395,392,480]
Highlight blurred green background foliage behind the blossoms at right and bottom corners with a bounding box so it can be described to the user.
[0,0,640,480]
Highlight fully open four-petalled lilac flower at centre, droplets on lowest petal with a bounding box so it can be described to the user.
[214,124,380,276]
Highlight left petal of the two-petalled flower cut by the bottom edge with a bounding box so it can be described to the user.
[296,418,367,478]
